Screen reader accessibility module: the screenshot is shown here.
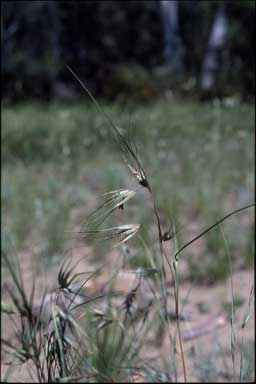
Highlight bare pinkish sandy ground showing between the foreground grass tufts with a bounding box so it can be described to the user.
[1,248,255,382]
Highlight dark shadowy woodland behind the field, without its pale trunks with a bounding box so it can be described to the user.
[1,0,255,101]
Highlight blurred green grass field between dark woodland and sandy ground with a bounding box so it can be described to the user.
[1,100,255,282]
